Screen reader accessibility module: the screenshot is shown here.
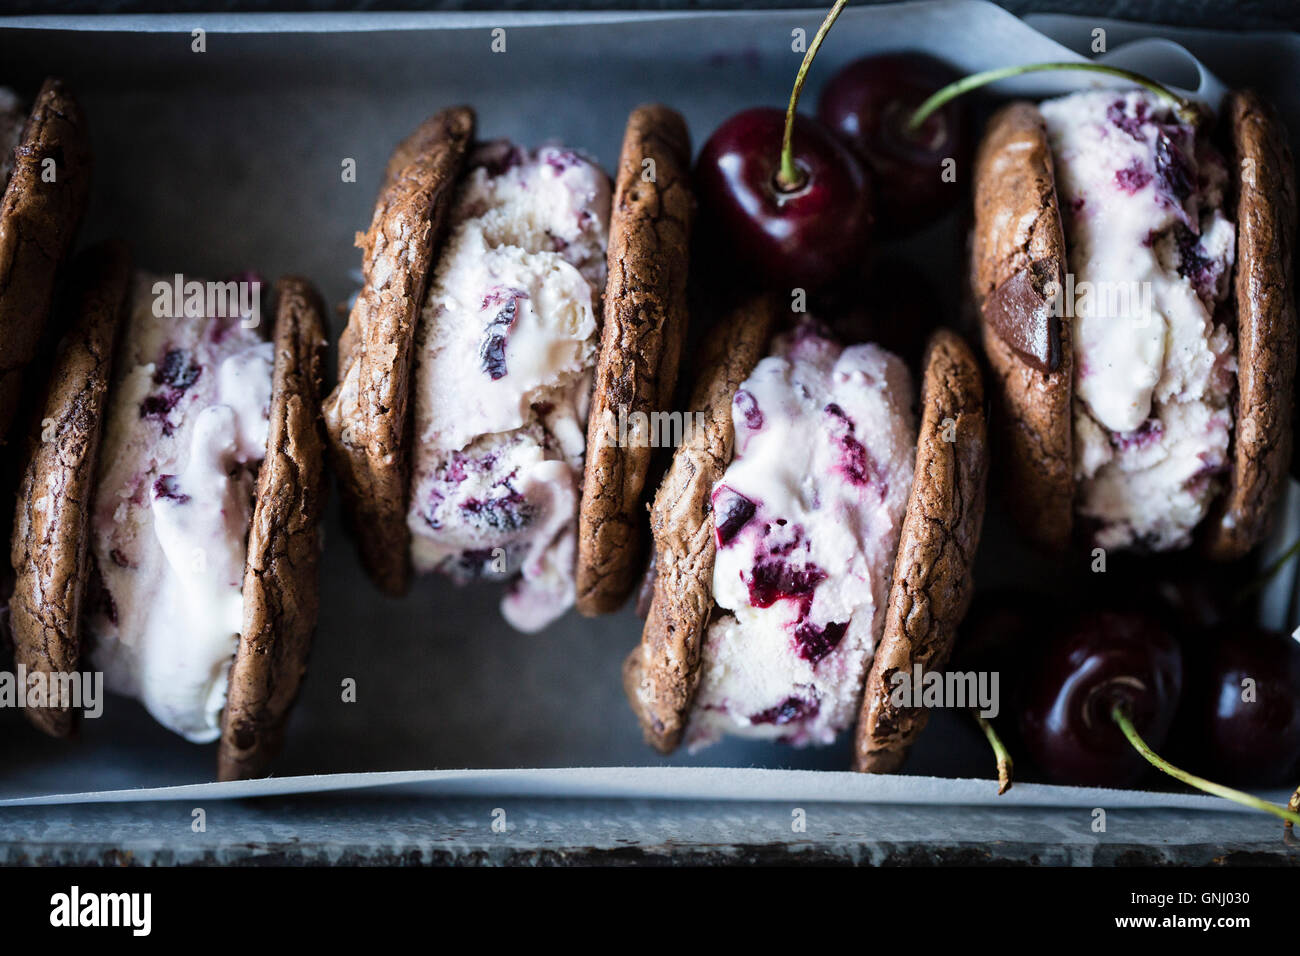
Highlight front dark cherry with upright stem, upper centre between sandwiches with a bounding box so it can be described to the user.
[696,108,872,289]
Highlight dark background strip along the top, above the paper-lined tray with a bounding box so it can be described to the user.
[0,0,1300,30]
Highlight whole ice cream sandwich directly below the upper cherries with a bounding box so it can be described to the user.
[624,298,987,771]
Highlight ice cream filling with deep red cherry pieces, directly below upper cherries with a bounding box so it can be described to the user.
[686,323,917,749]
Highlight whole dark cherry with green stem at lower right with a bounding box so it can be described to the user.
[1021,611,1183,787]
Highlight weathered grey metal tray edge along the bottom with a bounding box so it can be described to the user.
[0,797,1300,866]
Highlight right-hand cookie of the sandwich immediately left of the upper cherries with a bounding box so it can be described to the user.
[577,105,696,617]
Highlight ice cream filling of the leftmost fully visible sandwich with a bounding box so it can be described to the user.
[86,274,274,743]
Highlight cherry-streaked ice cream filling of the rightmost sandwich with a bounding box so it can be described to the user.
[1040,91,1236,550]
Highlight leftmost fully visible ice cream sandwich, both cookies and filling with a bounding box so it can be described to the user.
[9,243,325,779]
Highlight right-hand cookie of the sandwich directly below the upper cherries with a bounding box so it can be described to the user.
[854,329,988,773]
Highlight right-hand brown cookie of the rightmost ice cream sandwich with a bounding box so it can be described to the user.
[1203,91,1296,561]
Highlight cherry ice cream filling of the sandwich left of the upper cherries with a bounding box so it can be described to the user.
[407,143,610,631]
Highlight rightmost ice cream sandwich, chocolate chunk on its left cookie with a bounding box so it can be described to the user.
[971,90,1296,561]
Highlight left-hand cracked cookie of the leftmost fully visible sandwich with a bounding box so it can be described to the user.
[9,242,131,737]
